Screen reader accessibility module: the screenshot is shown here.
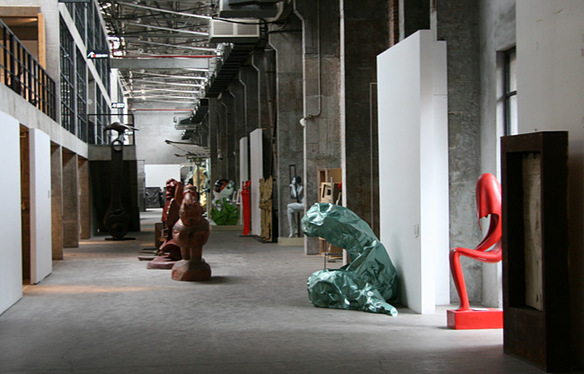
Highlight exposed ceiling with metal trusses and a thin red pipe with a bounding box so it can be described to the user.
[98,0,217,108]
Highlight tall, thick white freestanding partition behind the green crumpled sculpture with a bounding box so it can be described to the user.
[377,30,450,313]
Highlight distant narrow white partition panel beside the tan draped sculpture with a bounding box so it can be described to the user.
[249,129,264,235]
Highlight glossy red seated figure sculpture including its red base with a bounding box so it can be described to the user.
[447,173,503,329]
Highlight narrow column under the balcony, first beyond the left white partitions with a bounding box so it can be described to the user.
[51,144,63,260]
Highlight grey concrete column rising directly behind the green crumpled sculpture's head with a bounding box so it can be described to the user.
[295,0,341,254]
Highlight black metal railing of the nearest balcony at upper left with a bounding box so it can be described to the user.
[0,20,57,120]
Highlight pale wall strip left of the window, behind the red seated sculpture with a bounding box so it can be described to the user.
[480,0,515,307]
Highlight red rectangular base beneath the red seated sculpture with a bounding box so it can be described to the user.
[446,308,503,330]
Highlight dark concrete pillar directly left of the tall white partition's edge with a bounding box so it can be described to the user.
[340,0,389,235]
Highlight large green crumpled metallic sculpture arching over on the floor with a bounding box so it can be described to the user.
[302,203,398,316]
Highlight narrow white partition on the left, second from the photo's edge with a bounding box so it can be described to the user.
[29,129,53,284]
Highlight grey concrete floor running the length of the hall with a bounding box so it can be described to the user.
[0,211,564,374]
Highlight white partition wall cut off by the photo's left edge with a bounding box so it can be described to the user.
[0,112,22,313]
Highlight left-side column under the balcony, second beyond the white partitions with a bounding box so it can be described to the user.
[63,150,79,248]
